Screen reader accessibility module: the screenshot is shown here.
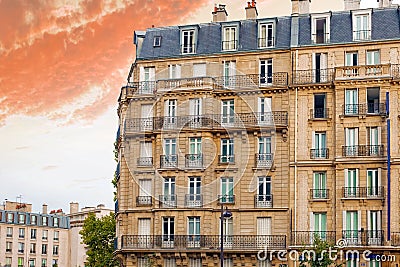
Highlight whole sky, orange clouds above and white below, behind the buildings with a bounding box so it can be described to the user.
[0,0,400,212]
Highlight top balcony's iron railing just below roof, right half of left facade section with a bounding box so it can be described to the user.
[215,72,288,89]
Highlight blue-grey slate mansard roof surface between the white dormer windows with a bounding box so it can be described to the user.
[135,8,400,60]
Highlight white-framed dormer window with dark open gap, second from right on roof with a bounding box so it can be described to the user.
[311,14,330,44]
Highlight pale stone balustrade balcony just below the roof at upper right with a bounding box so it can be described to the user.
[335,64,391,80]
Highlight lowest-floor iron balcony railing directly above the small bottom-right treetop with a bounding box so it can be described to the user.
[290,231,337,246]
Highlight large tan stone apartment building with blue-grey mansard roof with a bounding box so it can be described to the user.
[115,0,400,267]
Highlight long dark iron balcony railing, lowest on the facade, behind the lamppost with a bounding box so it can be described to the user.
[121,235,286,252]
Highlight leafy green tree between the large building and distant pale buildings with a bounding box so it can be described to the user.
[79,213,118,267]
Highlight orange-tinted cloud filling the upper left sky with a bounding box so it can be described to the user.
[0,0,208,122]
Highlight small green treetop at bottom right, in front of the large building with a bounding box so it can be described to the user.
[299,235,342,267]
